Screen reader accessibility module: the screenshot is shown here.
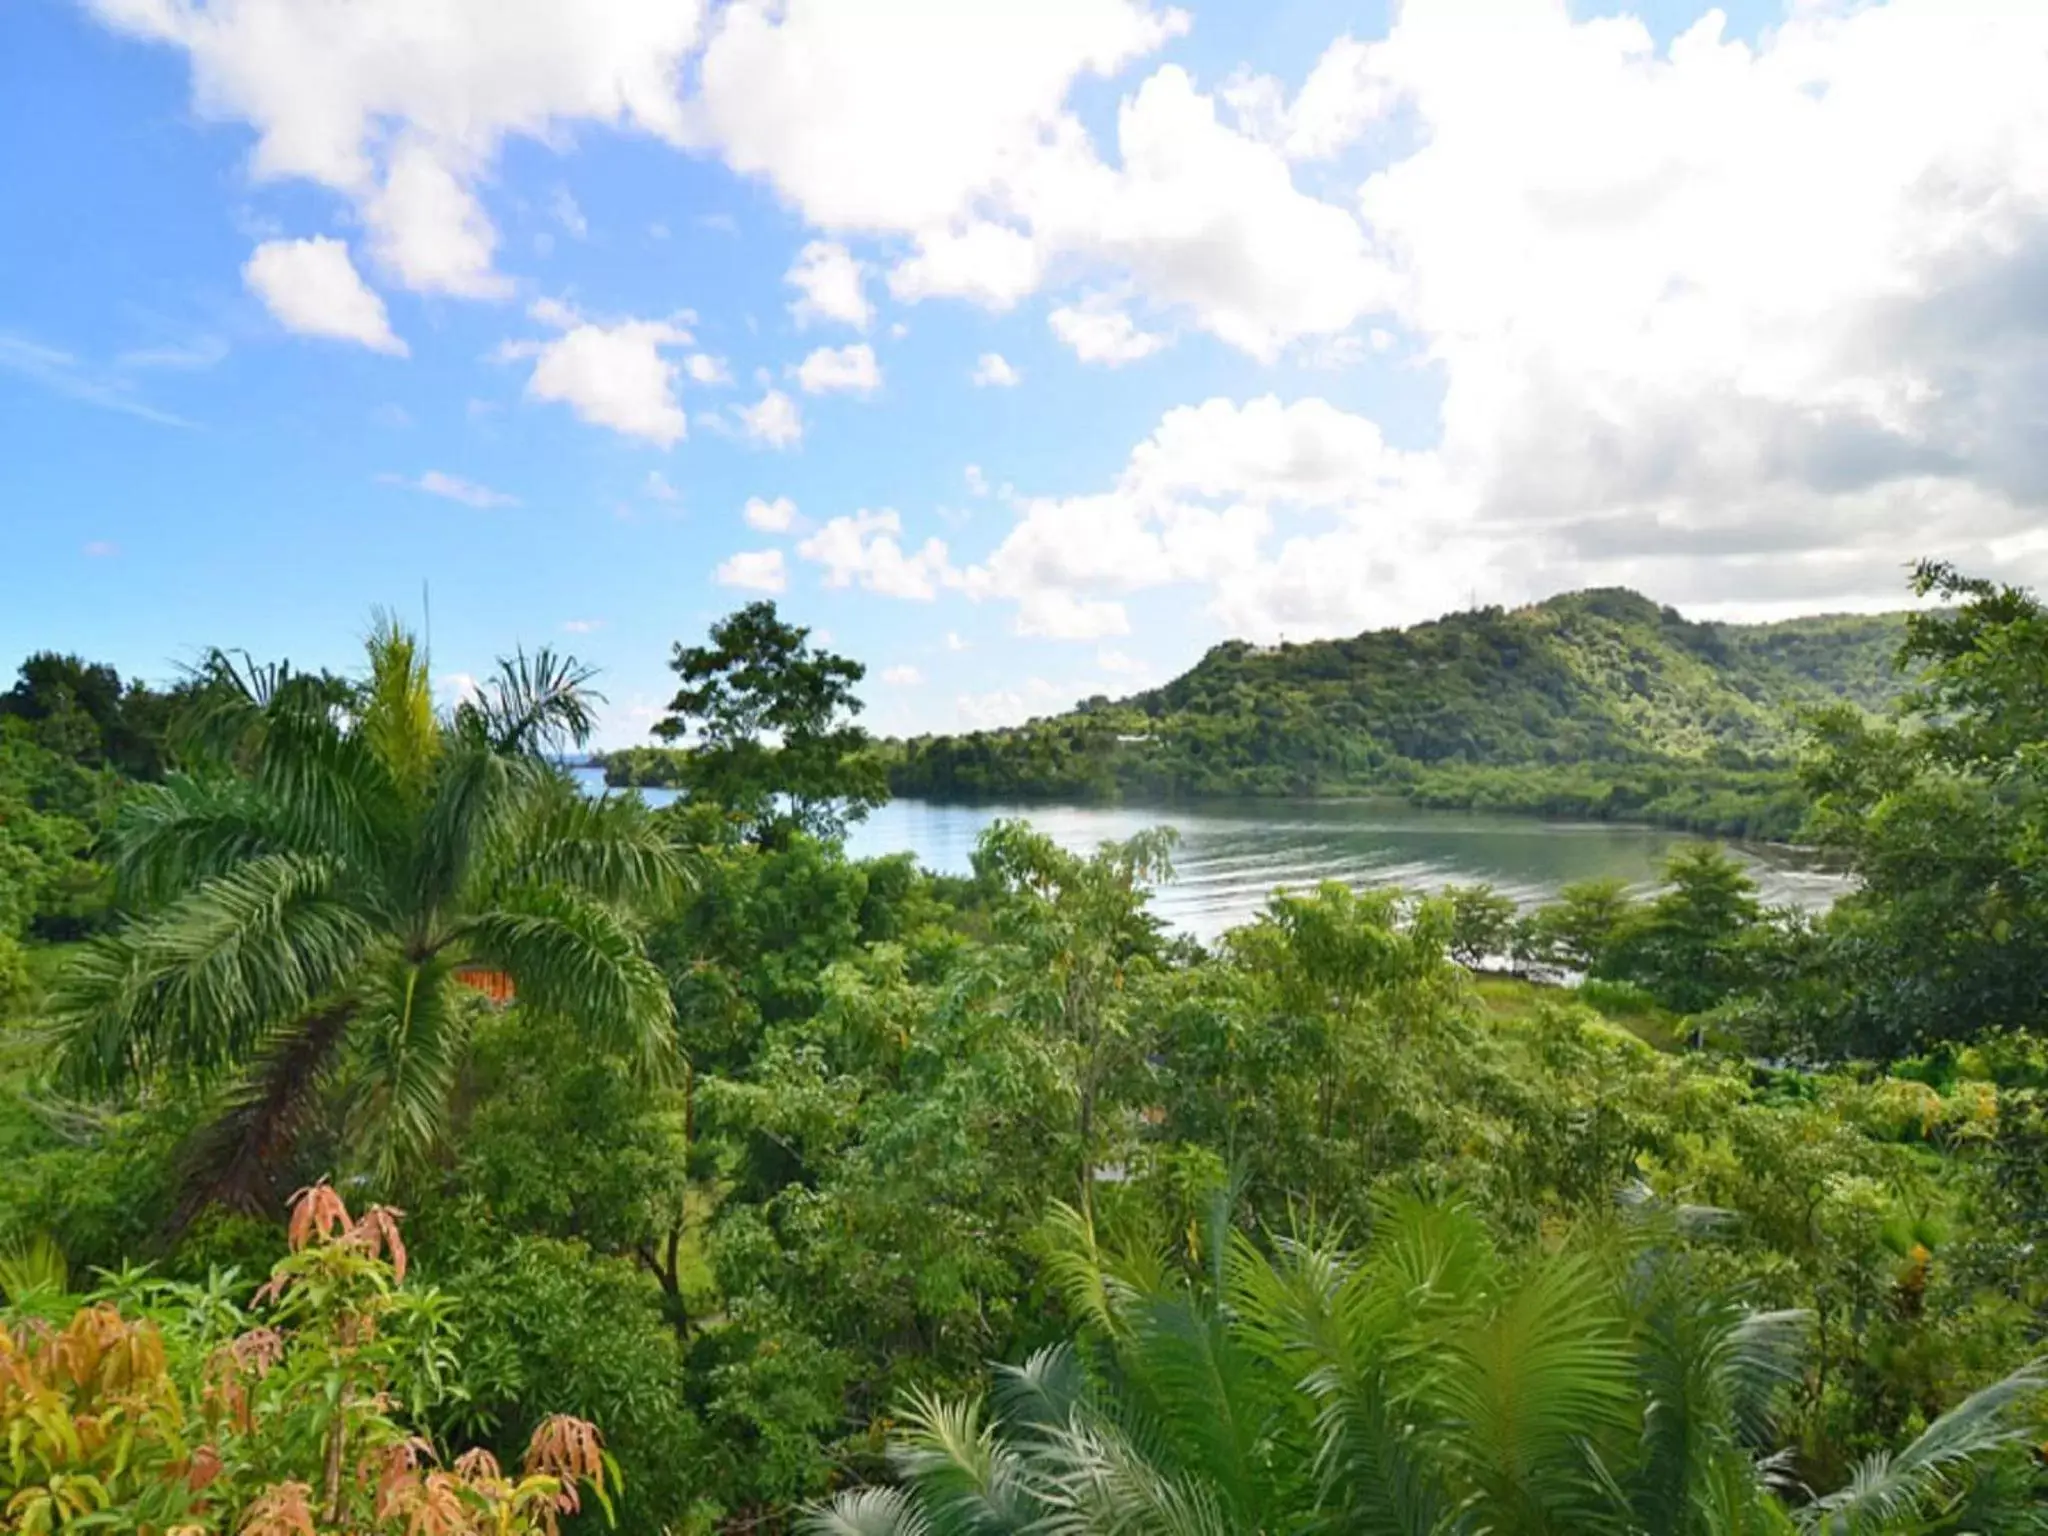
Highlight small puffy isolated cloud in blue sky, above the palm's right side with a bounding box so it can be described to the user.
[502,309,690,449]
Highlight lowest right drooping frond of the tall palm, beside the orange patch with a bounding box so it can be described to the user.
[455,887,676,1075]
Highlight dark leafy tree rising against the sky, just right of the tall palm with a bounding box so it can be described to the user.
[653,602,889,844]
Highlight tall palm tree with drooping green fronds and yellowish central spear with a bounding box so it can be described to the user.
[55,616,678,1208]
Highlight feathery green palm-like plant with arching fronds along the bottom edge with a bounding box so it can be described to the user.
[805,1200,2048,1536]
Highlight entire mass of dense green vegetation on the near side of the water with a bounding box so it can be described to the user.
[0,567,2048,1536]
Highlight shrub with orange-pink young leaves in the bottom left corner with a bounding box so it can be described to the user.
[0,1184,618,1536]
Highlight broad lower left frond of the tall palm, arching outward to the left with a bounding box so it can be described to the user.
[51,854,373,1092]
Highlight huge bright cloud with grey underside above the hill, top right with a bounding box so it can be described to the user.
[1335,0,2048,606]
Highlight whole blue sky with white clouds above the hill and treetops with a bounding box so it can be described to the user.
[0,0,2048,745]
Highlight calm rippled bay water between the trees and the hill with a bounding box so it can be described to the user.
[580,770,1847,940]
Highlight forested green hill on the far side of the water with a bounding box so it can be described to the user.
[889,588,1903,836]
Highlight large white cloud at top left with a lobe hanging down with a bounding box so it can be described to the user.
[90,0,700,297]
